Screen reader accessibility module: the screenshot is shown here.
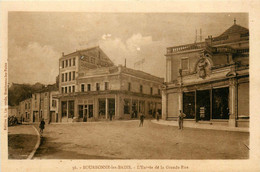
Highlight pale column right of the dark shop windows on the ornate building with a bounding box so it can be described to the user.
[229,78,237,127]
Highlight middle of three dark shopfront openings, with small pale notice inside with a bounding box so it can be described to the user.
[196,90,210,121]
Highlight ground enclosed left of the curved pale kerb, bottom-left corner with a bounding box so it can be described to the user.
[8,125,37,159]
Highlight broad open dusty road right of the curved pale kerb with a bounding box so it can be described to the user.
[34,120,249,159]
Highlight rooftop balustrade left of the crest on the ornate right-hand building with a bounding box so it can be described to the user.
[167,42,206,54]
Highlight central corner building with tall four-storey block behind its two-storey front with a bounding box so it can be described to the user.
[57,47,163,122]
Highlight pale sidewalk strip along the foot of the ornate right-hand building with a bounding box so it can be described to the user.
[151,119,249,132]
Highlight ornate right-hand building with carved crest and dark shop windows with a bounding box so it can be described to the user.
[162,21,249,127]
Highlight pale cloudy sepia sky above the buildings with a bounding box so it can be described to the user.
[8,12,248,84]
